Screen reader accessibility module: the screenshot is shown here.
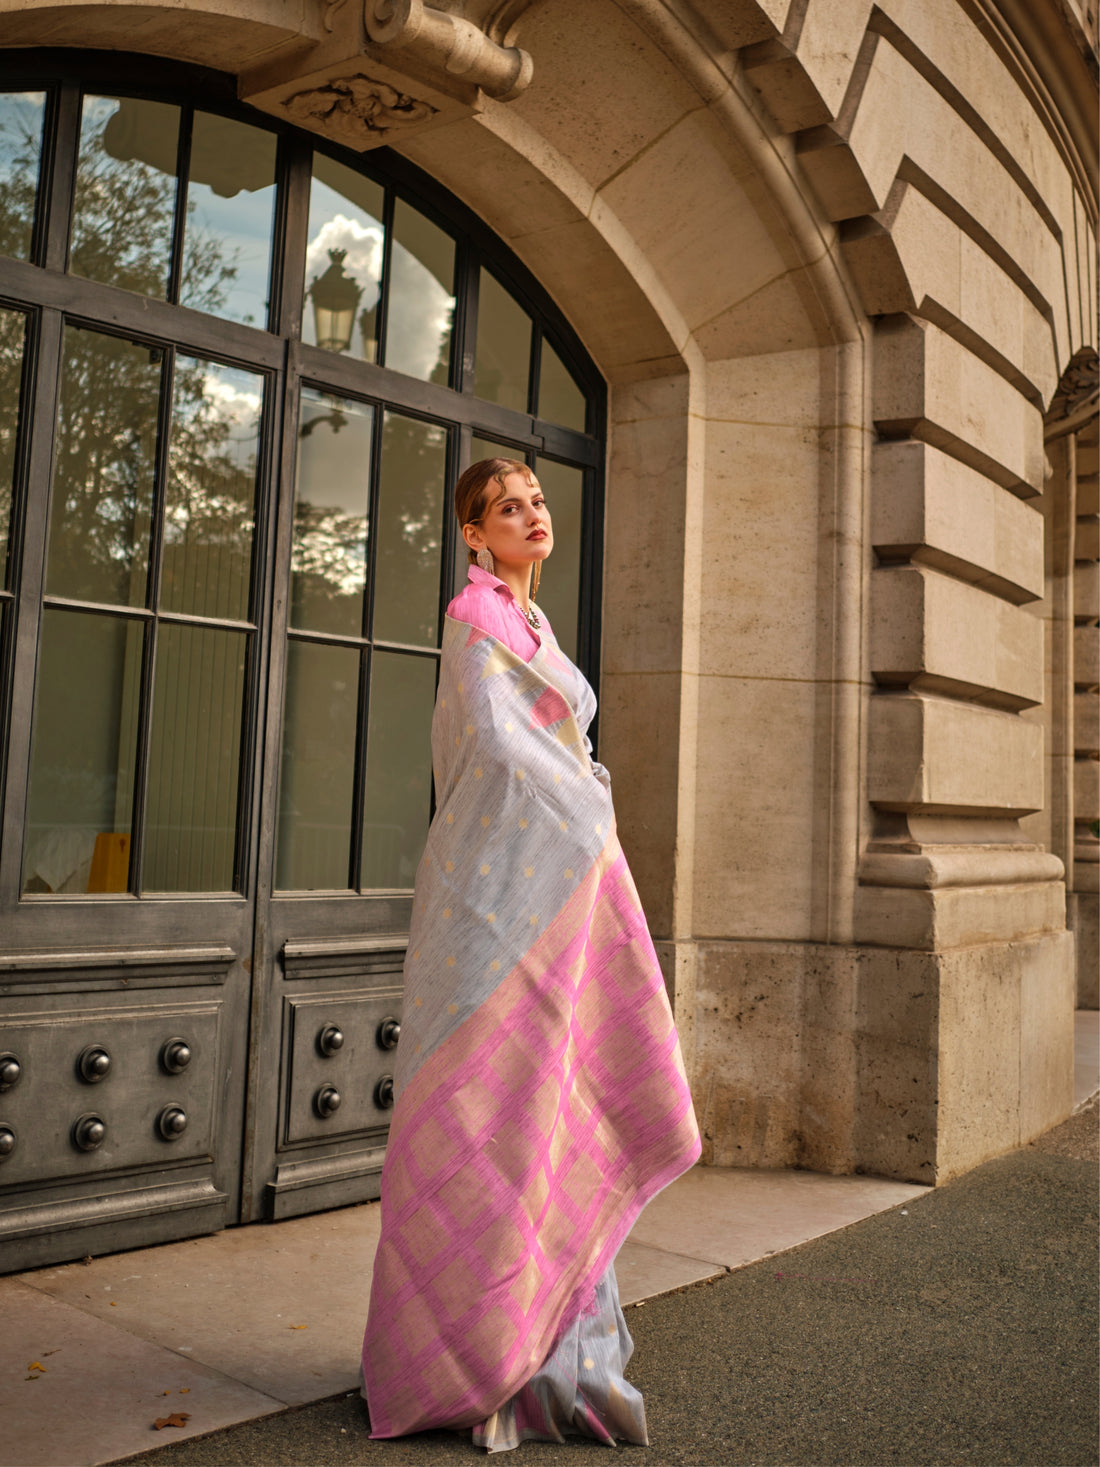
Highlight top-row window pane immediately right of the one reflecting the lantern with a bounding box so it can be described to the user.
[386,198,455,383]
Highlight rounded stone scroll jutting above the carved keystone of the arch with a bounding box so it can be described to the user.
[362,0,534,101]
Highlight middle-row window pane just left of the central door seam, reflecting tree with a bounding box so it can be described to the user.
[160,366,264,621]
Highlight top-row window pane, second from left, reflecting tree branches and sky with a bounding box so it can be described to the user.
[69,97,179,301]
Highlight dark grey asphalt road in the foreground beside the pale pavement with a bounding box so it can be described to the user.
[128,1102,1100,1467]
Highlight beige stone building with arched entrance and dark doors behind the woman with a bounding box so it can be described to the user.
[0,0,1100,1267]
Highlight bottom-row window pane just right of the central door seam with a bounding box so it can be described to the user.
[276,641,361,890]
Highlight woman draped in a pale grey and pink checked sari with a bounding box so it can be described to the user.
[362,459,700,1451]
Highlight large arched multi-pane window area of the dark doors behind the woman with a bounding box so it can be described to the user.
[0,56,603,902]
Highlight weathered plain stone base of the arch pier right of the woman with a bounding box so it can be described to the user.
[692,932,1075,1184]
